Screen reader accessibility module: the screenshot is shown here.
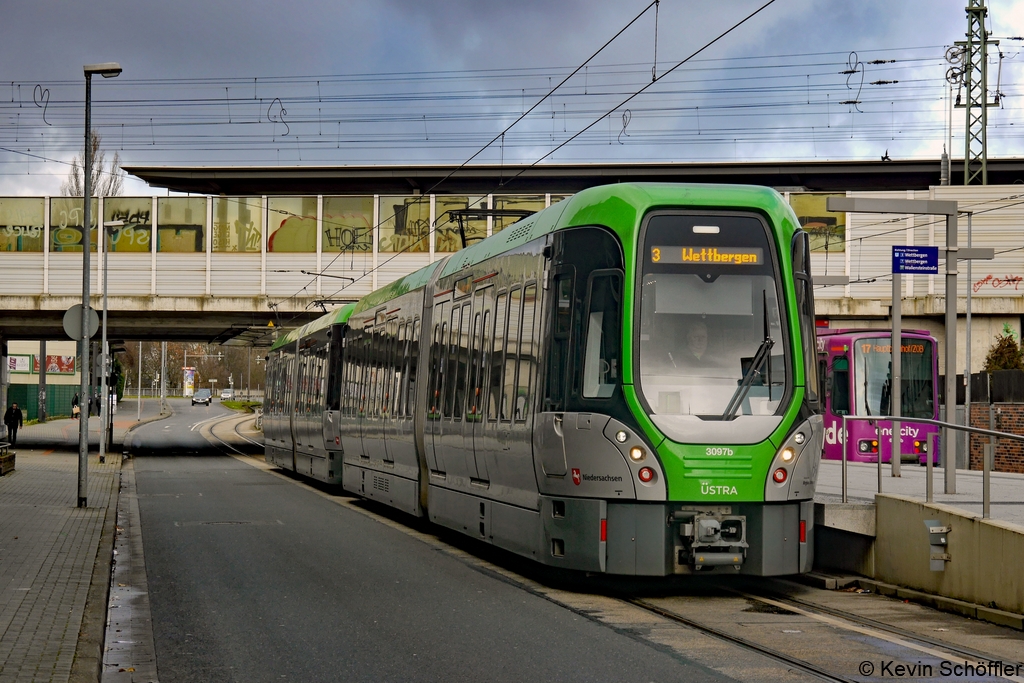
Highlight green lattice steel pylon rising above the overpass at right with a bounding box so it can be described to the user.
[955,0,998,185]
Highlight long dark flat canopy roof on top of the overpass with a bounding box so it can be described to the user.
[125,159,1024,196]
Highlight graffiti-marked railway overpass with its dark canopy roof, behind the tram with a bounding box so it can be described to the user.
[0,160,1024,352]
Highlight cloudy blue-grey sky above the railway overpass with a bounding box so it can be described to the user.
[0,0,1024,196]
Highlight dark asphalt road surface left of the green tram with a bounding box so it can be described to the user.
[132,401,729,683]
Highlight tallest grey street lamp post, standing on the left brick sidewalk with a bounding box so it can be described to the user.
[78,61,121,508]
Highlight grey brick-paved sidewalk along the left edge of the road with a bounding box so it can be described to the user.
[0,450,121,683]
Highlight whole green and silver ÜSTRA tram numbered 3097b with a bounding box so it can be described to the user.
[264,184,822,575]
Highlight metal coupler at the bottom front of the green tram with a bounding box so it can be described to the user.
[669,506,749,571]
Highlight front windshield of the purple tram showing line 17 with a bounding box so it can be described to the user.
[853,337,935,419]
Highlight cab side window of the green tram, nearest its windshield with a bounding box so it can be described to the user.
[583,271,622,398]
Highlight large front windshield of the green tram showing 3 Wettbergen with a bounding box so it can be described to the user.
[637,214,788,421]
